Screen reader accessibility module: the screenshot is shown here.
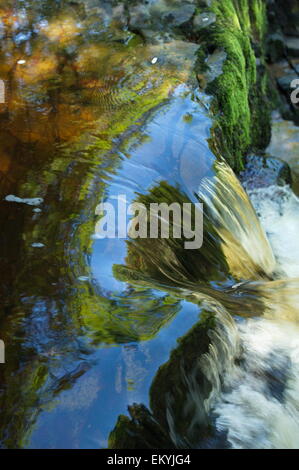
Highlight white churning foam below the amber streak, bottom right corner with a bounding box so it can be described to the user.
[215,319,299,449]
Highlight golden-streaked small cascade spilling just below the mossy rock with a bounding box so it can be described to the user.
[198,161,275,280]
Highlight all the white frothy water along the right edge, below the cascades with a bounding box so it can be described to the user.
[213,186,299,449]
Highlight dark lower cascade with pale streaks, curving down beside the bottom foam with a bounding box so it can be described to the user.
[154,299,240,448]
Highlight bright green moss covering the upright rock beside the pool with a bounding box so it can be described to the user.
[198,0,271,171]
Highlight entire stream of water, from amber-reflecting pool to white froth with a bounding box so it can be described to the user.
[0,0,299,448]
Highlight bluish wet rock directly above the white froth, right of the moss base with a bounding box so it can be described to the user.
[240,155,292,190]
